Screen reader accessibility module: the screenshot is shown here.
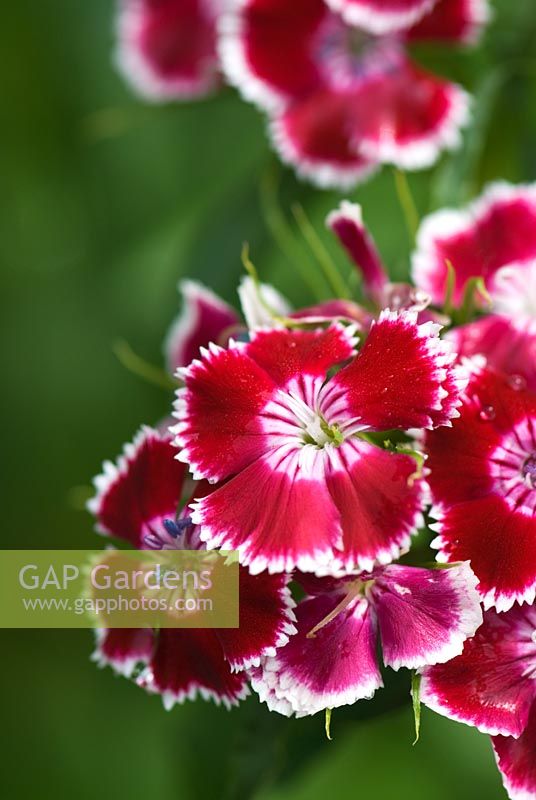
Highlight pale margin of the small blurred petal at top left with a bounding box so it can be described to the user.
[114,0,218,103]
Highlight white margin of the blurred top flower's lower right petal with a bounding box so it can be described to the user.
[355,84,471,170]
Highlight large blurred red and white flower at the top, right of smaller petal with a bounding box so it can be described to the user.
[220,0,487,188]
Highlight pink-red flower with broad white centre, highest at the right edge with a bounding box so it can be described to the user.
[413,183,536,391]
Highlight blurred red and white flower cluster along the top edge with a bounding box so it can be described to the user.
[117,0,489,187]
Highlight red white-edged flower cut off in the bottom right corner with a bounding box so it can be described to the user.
[420,606,536,800]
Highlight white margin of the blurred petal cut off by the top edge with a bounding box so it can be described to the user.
[326,0,437,36]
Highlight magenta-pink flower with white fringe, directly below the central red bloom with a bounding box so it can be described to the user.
[250,564,482,717]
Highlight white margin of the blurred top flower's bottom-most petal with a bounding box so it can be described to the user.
[268,117,378,191]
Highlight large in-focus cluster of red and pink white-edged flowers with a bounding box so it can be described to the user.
[90,180,536,800]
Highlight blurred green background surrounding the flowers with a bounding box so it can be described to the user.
[0,0,536,800]
